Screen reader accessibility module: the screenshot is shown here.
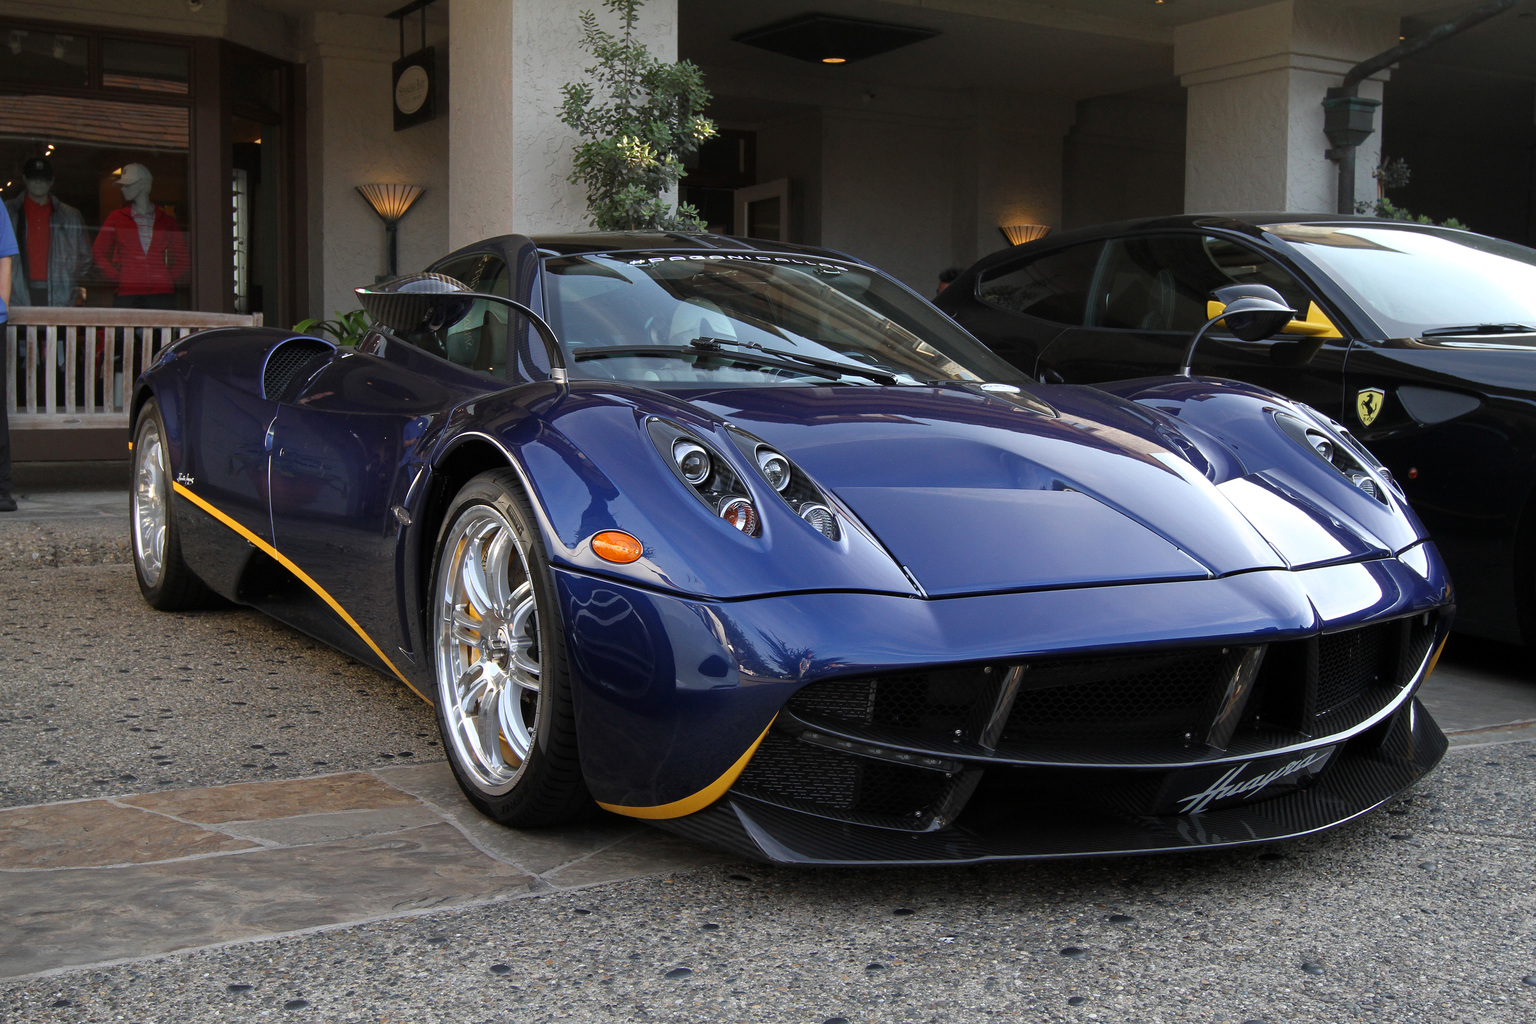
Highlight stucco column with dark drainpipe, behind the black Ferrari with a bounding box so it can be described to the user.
[1174,0,1398,212]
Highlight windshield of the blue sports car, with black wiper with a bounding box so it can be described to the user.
[544,253,1020,385]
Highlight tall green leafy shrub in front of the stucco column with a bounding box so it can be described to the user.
[561,0,714,230]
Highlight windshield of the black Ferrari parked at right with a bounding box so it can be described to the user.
[1266,223,1536,338]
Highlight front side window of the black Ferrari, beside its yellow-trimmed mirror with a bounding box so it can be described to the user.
[1087,233,1310,332]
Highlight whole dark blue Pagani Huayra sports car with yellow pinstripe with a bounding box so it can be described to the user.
[132,233,1452,864]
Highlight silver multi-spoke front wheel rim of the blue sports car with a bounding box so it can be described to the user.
[433,504,541,795]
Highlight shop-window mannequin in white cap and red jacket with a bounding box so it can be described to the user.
[92,164,192,309]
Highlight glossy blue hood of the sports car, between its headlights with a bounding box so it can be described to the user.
[690,384,1392,596]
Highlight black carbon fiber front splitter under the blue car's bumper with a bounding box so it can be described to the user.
[656,699,1448,866]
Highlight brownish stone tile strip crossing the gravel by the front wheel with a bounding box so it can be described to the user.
[0,761,725,978]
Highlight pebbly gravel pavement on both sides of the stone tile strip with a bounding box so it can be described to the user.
[0,534,1536,1024]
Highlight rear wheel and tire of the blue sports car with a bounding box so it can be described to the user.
[127,399,215,611]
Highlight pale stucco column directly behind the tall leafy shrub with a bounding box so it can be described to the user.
[449,0,677,247]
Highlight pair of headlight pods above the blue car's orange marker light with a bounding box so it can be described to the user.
[645,418,840,540]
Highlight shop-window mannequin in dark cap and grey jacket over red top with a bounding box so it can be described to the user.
[6,157,91,306]
